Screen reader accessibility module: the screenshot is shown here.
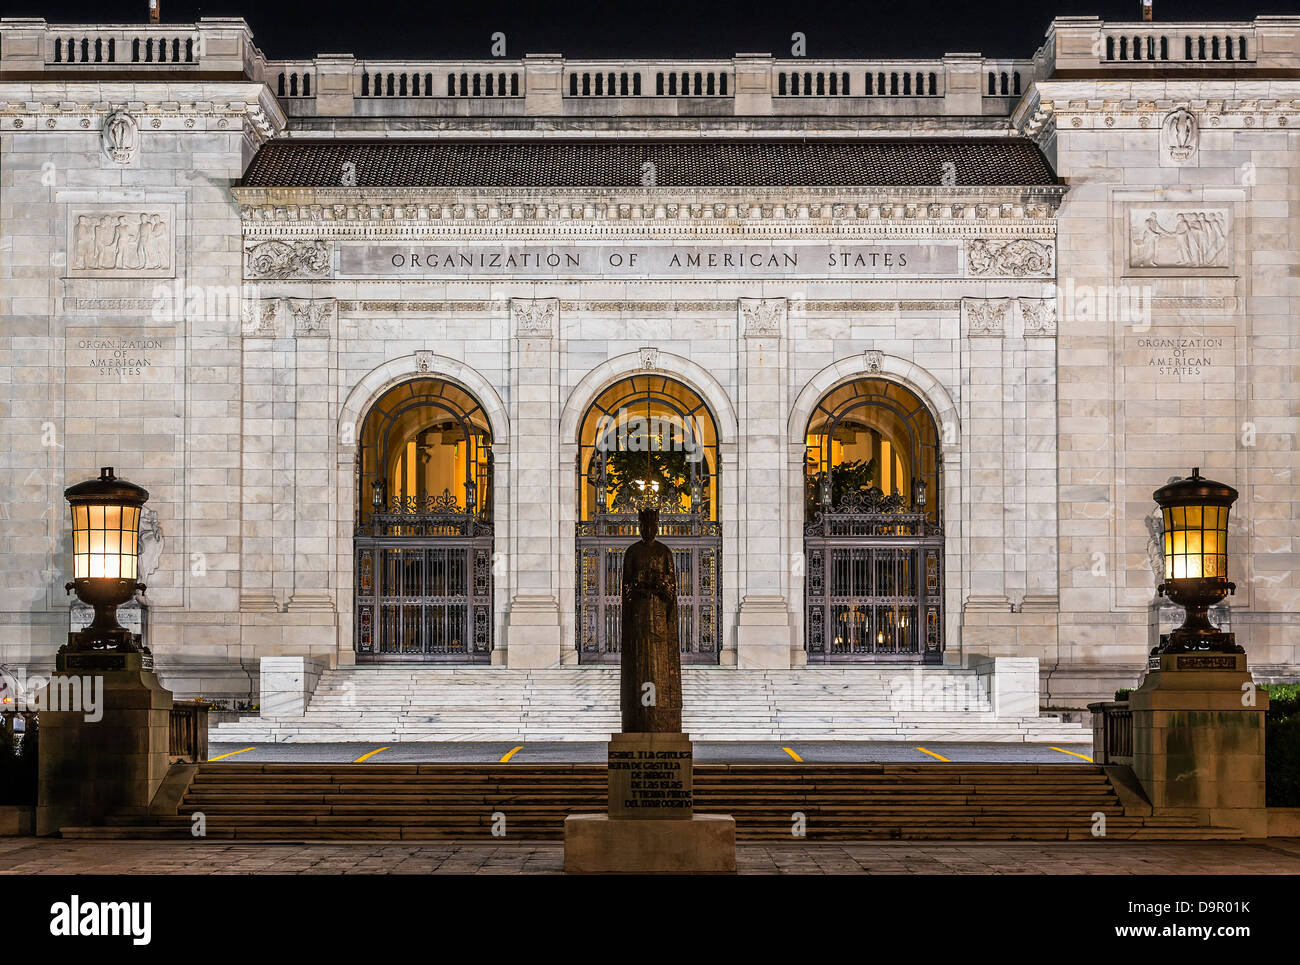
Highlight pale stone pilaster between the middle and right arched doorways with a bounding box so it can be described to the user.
[736,298,793,668]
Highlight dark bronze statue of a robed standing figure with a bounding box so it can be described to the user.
[620,509,681,734]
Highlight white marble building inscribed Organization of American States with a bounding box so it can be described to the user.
[0,17,1300,706]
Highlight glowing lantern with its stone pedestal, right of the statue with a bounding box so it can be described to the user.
[1128,469,1269,838]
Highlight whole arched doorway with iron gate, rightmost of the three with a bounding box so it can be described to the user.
[803,378,944,663]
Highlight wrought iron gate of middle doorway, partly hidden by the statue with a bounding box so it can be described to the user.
[577,512,723,663]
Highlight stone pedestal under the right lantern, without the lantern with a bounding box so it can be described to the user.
[1128,652,1269,838]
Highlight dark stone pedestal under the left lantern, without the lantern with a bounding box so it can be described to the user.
[36,652,172,835]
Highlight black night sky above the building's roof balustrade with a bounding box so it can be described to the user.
[12,0,1300,60]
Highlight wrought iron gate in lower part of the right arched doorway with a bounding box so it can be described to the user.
[803,492,944,663]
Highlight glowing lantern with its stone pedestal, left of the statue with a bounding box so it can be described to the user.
[36,468,172,835]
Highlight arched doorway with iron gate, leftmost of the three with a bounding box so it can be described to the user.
[354,378,493,663]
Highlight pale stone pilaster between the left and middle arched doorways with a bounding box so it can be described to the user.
[504,298,562,667]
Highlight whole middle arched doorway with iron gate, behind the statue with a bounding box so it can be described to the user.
[576,375,722,663]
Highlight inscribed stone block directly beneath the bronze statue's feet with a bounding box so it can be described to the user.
[610,734,693,819]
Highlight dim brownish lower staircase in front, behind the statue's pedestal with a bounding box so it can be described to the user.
[61,762,1242,847]
